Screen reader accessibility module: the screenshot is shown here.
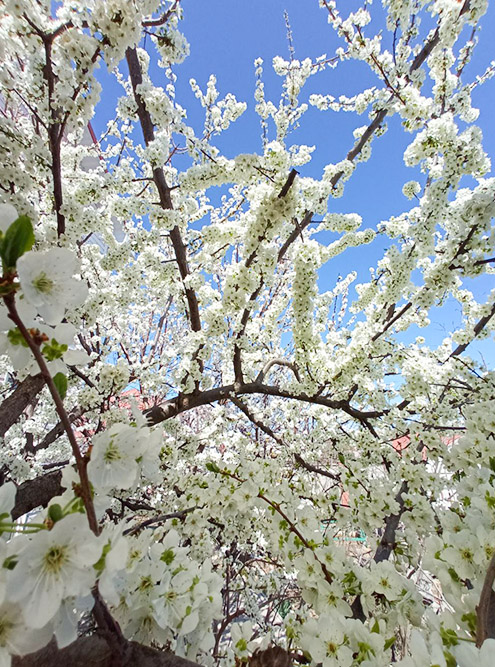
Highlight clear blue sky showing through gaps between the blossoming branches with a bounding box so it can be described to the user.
[94,0,495,364]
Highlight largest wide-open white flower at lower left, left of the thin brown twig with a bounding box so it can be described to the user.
[8,514,102,628]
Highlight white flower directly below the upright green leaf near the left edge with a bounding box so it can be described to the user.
[17,248,88,324]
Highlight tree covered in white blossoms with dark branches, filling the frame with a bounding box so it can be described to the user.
[0,0,495,667]
